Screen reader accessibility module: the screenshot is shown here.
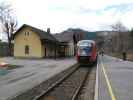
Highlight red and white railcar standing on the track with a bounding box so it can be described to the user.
[76,40,97,64]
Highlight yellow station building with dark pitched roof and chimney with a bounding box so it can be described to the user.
[13,24,59,58]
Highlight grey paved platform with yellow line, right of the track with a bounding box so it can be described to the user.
[98,55,133,100]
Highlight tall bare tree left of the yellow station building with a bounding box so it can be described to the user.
[0,3,17,55]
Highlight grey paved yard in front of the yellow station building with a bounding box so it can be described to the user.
[0,58,76,100]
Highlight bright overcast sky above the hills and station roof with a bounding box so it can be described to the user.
[0,0,133,33]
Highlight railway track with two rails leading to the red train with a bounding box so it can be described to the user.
[33,67,91,100]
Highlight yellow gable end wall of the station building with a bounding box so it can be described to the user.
[14,27,43,58]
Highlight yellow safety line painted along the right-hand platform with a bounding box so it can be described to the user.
[101,62,116,100]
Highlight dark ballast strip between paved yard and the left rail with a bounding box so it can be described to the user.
[8,64,79,100]
